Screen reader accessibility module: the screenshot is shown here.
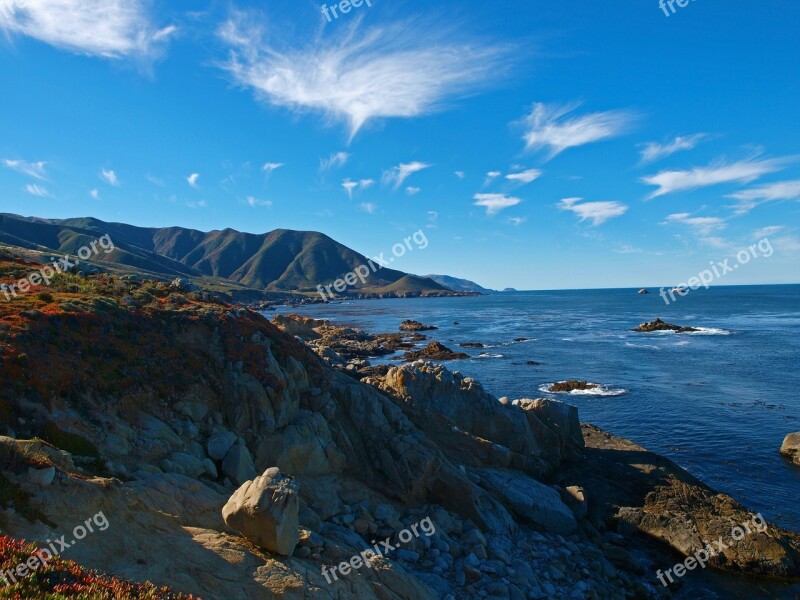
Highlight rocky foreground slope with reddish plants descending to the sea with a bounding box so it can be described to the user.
[0,252,800,600]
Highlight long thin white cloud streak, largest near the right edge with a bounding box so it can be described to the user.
[641,158,789,198]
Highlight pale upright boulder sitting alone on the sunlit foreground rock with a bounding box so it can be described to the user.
[222,467,300,556]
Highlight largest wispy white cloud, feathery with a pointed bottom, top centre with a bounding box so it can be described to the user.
[219,12,511,139]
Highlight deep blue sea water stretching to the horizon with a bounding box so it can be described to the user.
[281,285,800,532]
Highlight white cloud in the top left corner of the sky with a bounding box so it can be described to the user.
[0,0,176,58]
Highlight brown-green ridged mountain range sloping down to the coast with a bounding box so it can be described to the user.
[0,214,460,296]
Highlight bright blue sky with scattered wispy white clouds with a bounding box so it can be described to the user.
[0,0,800,289]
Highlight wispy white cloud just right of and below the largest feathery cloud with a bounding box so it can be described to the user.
[523,103,636,158]
